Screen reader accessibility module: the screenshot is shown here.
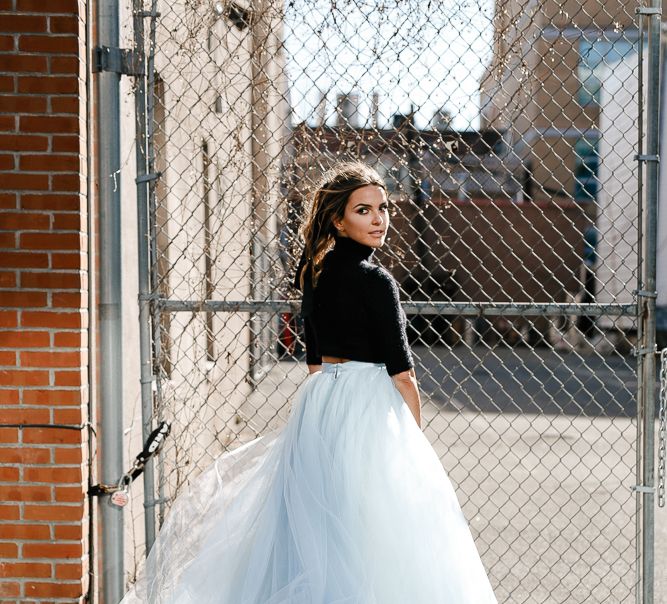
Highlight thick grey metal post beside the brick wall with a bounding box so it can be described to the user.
[97,0,124,604]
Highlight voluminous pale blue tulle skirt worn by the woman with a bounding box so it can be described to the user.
[123,361,496,604]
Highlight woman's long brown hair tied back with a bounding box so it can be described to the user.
[299,162,387,289]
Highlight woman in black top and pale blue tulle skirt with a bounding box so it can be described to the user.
[123,163,496,604]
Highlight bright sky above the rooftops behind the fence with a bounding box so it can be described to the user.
[285,0,494,130]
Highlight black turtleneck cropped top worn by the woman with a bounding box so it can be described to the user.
[294,237,414,375]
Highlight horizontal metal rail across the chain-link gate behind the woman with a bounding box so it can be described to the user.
[156,299,637,317]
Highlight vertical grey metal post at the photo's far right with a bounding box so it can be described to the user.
[638,0,662,604]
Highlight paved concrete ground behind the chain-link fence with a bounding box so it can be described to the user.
[247,347,667,604]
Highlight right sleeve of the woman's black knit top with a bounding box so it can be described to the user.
[367,267,415,375]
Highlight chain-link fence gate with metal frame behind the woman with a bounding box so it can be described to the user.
[122,0,664,603]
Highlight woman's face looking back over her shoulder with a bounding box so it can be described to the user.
[334,185,389,247]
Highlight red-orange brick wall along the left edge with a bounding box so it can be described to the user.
[0,0,89,602]
